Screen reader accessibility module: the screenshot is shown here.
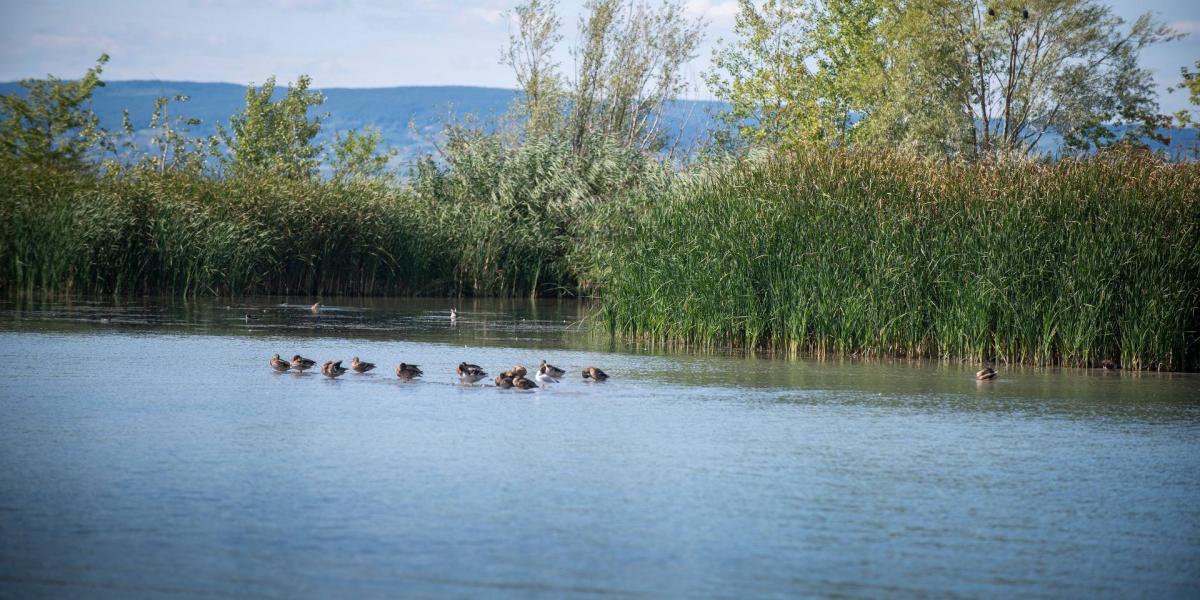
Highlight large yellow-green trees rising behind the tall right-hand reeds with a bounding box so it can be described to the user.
[708,0,1175,157]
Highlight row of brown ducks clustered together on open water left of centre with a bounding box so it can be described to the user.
[271,354,608,390]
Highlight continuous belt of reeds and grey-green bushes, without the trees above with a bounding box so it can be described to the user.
[0,144,1200,370]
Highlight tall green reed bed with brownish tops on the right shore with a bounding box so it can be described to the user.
[598,152,1200,370]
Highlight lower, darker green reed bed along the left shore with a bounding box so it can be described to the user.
[0,164,452,295]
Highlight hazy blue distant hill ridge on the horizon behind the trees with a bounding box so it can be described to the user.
[0,80,721,164]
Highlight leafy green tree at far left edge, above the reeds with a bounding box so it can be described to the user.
[0,54,110,168]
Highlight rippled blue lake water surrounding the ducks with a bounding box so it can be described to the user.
[0,299,1200,599]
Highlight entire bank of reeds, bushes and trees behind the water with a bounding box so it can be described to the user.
[7,0,1200,370]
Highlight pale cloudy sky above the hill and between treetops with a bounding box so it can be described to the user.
[0,0,1200,112]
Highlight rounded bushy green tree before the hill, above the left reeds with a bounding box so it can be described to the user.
[218,76,325,179]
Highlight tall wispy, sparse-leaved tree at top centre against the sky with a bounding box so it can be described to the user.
[500,0,703,155]
